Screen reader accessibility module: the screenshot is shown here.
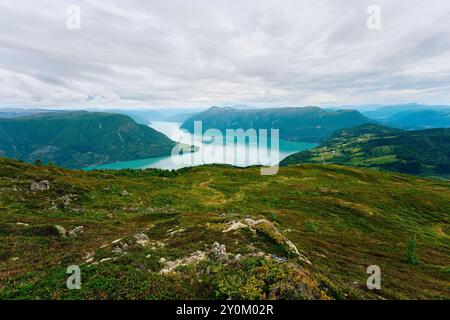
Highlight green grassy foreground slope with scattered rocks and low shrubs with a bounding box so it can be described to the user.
[0,158,450,299]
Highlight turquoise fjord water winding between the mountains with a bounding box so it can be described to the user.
[86,121,317,170]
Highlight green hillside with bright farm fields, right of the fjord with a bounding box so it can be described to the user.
[281,124,450,177]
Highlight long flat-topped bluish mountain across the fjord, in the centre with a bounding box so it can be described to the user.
[182,107,371,142]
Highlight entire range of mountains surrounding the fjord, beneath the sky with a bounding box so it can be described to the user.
[0,104,450,176]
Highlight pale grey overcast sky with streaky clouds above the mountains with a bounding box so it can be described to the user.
[0,0,450,108]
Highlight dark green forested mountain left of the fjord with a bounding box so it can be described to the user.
[0,111,175,168]
